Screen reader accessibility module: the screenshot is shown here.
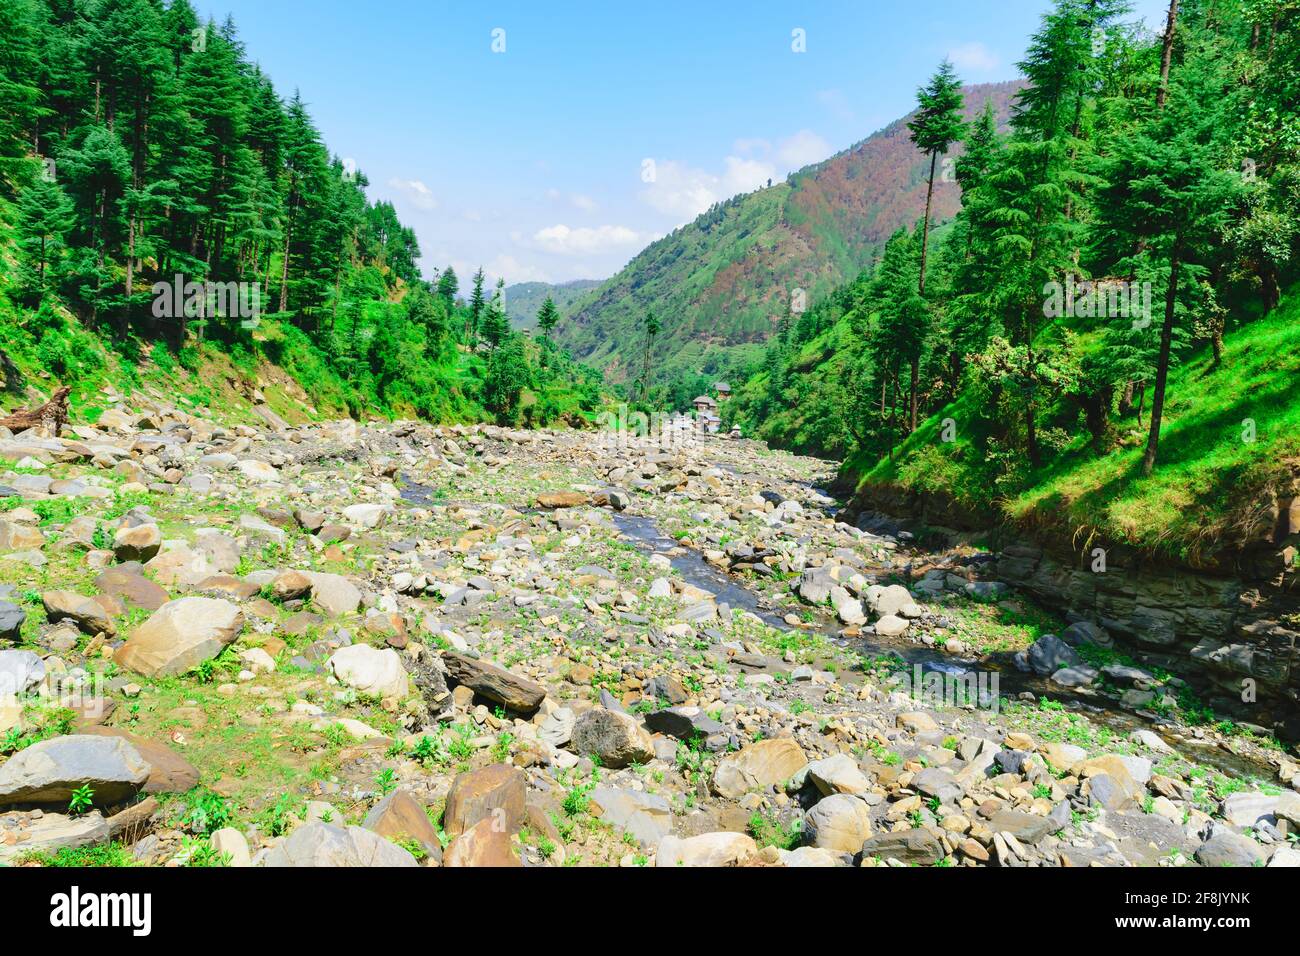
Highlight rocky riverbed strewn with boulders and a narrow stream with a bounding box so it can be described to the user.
[0,405,1300,866]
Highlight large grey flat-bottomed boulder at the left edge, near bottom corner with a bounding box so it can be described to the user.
[0,734,150,806]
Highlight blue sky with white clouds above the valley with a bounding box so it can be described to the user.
[195,0,1167,282]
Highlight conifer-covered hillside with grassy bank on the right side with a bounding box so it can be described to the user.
[731,0,1300,557]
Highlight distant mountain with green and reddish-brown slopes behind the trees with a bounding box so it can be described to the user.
[556,81,1022,390]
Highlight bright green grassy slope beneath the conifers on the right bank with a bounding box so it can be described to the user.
[844,290,1300,558]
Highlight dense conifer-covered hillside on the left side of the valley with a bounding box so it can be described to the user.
[0,0,601,424]
